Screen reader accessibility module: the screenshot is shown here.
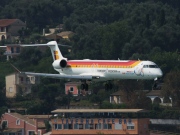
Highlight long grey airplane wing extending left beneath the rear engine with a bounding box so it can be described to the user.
[21,72,93,80]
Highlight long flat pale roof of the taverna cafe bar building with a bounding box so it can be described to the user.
[51,109,147,113]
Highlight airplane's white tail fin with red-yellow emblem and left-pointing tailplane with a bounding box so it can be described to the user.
[20,41,67,61]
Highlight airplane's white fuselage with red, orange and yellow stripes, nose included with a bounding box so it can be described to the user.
[55,60,162,80]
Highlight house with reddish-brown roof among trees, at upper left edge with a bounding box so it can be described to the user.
[0,19,26,41]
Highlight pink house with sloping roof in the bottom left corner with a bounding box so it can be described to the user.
[1,113,46,135]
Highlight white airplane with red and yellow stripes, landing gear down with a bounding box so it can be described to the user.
[4,41,163,90]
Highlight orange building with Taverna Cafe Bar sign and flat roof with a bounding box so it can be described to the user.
[51,109,150,135]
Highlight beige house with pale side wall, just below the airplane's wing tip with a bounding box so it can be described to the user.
[6,73,40,98]
